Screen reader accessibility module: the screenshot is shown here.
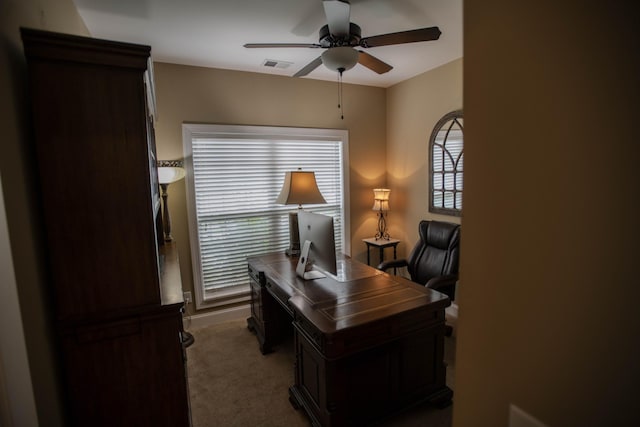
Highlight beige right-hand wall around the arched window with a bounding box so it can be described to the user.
[386,59,466,256]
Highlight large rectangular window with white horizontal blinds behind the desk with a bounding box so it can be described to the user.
[183,124,350,308]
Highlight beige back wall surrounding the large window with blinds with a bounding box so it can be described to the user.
[154,63,387,314]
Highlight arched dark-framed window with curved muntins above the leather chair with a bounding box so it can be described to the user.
[429,110,464,216]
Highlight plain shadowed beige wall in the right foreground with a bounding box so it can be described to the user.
[453,0,640,427]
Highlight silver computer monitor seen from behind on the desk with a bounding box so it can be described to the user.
[296,211,337,279]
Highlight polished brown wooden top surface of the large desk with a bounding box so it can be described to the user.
[248,253,450,333]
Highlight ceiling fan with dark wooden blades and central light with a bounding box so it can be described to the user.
[244,0,441,77]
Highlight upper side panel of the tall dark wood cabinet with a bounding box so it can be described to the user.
[30,62,160,319]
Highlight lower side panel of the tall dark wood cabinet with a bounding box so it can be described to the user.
[62,312,189,427]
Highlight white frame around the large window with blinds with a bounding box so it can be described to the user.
[182,123,351,310]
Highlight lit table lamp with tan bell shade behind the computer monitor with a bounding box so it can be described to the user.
[276,168,327,257]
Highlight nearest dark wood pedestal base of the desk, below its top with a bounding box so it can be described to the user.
[289,300,453,426]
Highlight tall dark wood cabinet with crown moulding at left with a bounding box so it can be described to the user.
[22,29,190,427]
